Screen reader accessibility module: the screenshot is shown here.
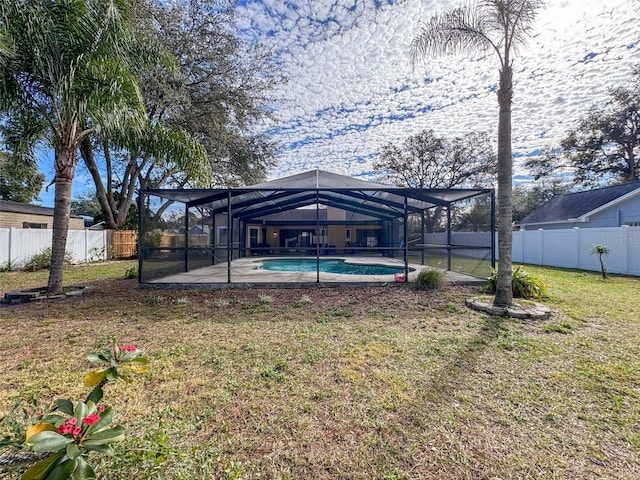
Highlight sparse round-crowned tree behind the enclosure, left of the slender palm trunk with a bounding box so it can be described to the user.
[374,130,496,232]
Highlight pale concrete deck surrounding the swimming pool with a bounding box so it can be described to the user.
[142,255,486,288]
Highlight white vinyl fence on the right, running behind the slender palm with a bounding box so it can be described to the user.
[426,226,640,276]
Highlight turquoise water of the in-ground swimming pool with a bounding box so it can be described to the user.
[257,258,415,275]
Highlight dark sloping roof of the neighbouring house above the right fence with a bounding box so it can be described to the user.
[518,181,640,225]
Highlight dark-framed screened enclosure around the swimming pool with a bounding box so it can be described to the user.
[138,170,495,287]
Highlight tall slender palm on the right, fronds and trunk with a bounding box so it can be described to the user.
[411,0,543,306]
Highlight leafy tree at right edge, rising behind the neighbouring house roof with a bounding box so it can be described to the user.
[527,65,640,187]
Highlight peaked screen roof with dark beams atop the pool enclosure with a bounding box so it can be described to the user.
[145,170,491,221]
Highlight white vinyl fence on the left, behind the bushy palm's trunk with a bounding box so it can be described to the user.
[0,227,107,268]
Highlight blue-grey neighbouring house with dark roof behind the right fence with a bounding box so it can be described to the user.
[516,181,640,230]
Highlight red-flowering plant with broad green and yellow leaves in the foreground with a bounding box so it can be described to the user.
[0,341,148,480]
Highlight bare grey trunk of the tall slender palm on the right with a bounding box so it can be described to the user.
[493,63,513,307]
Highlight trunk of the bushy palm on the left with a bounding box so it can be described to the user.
[47,142,76,293]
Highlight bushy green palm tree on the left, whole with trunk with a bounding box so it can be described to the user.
[0,0,144,292]
